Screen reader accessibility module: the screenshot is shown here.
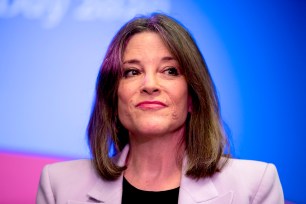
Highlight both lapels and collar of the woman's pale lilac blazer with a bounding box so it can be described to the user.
[88,145,233,204]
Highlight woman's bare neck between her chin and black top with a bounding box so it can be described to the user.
[124,129,184,191]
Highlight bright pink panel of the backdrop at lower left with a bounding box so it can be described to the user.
[0,152,64,204]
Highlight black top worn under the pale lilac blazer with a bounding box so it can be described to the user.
[122,177,180,204]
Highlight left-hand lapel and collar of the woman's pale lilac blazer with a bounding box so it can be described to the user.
[87,145,129,204]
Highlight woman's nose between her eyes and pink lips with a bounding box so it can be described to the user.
[141,73,160,95]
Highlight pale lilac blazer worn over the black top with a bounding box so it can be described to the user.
[36,147,284,204]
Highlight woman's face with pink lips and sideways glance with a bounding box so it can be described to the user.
[118,32,191,137]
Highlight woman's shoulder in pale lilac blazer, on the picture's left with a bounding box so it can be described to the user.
[36,160,99,203]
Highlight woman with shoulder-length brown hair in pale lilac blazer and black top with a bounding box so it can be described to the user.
[37,14,284,204]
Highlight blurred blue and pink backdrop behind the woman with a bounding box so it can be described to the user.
[0,0,306,203]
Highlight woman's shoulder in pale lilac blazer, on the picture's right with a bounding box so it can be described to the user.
[212,159,283,203]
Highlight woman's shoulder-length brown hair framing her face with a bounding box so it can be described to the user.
[87,13,228,180]
